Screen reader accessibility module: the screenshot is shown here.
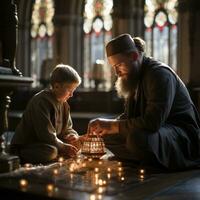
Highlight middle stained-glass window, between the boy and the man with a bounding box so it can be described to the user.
[83,0,113,88]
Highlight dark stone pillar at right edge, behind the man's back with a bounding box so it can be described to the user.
[178,0,200,87]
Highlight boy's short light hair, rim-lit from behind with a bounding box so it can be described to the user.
[50,64,81,86]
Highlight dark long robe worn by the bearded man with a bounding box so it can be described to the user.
[119,57,200,169]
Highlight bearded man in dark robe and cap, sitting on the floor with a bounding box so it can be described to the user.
[88,34,200,170]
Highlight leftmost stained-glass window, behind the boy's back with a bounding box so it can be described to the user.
[31,0,54,86]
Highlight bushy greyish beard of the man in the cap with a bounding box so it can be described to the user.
[115,67,138,99]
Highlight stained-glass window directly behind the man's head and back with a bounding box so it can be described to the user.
[144,0,177,71]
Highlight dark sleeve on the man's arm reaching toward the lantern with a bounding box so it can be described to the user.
[119,69,176,134]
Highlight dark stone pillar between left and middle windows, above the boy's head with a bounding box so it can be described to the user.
[54,14,82,73]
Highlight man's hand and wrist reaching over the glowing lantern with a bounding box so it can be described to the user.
[88,118,119,135]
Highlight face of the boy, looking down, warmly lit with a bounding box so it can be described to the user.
[53,83,78,102]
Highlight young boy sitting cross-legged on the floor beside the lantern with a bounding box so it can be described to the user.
[11,64,81,163]
